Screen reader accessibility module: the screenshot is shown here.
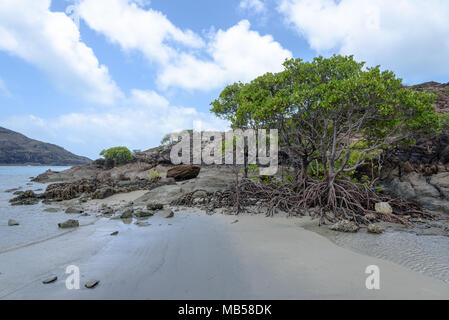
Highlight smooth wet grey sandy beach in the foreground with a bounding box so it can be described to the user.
[0,191,449,299]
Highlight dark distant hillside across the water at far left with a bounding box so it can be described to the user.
[0,127,91,166]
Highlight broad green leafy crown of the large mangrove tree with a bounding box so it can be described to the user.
[211,55,439,177]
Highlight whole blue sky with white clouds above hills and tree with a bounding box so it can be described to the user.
[0,0,449,159]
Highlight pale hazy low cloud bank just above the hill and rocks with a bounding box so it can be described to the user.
[0,90,228,158]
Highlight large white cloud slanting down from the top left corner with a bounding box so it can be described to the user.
[0,0,122,104]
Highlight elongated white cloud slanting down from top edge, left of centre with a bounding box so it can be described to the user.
[78,0,204,64]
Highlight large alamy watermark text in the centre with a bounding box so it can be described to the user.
[170,129,279,176]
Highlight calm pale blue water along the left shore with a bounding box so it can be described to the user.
[0,166,68,252]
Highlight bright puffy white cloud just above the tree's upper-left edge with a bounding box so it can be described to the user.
[158,20,292,90]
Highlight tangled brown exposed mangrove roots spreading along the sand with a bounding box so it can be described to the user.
[172,179,433,225]
